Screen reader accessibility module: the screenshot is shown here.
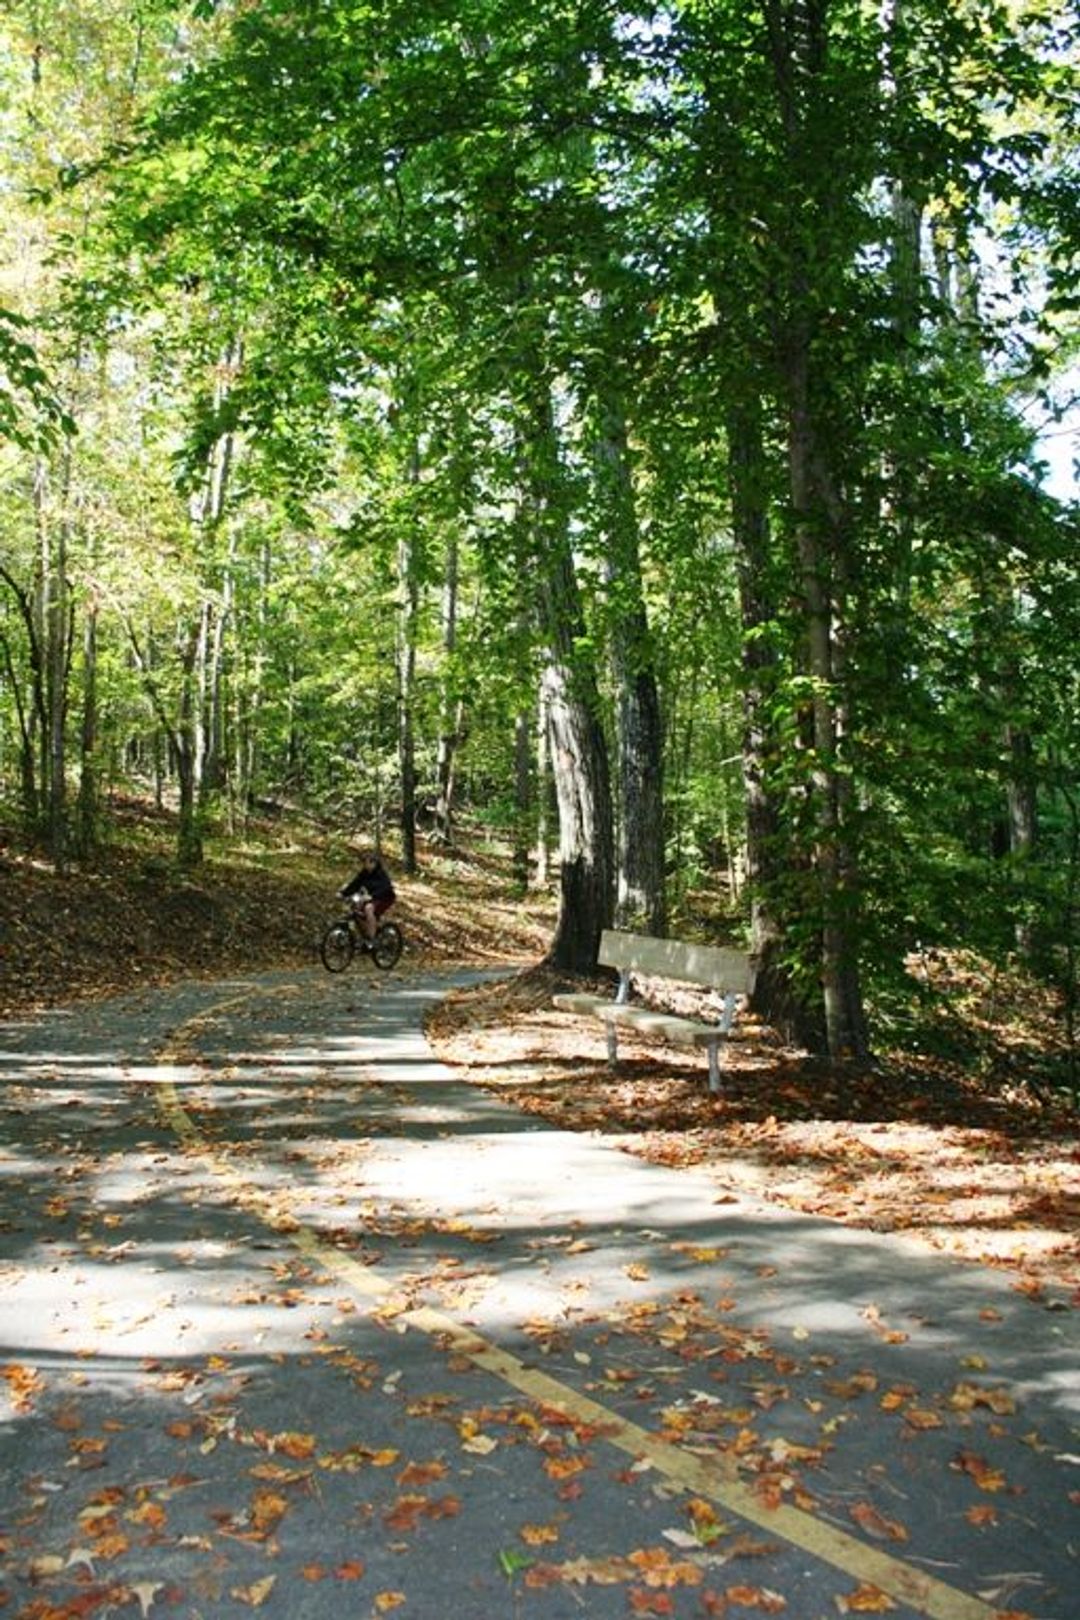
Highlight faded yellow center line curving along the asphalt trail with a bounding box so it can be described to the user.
[155,990,1001,1620]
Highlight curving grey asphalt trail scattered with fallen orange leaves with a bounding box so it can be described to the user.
[0,966,1080,1620]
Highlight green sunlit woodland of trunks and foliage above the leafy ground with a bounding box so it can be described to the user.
[0,0,1080,1075]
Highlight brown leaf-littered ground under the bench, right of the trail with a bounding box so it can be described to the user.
[427,969,1080,1302]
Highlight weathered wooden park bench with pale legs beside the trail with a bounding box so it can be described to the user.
[552,928,753,1092]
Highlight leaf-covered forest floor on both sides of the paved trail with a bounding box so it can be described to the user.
[0,805,1080,1307]
